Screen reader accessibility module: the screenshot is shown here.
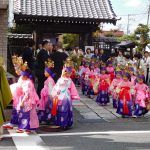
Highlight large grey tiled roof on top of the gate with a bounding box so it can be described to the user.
[14,0,116,20]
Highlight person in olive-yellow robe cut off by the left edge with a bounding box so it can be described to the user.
[0,57,12,140]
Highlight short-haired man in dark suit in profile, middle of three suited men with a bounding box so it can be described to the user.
[36,41,50,97]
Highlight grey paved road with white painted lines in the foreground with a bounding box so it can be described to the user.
[0,88,150,150]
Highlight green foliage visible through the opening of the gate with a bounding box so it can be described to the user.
[63,34,79,48]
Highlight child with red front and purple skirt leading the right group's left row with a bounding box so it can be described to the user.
[96,67,110,106]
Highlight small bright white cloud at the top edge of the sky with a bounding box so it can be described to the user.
[124,0,142,8]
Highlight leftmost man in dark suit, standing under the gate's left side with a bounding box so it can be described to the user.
[22,40,35,70]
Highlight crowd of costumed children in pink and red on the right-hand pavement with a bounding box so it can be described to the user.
[78,54,150,118]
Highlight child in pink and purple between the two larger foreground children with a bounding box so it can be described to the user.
[38,59,55,123]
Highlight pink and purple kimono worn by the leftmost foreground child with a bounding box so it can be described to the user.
[10,76,39,130]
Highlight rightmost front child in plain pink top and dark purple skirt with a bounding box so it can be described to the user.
[134,75,148,117]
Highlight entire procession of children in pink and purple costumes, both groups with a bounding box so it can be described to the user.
[0,49,150,141]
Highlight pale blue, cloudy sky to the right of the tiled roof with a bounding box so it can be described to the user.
[103,0,150,33]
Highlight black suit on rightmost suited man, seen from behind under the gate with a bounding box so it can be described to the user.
[50,51,68,82]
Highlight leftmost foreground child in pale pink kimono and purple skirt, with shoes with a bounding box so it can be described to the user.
[3,58,39,133]
